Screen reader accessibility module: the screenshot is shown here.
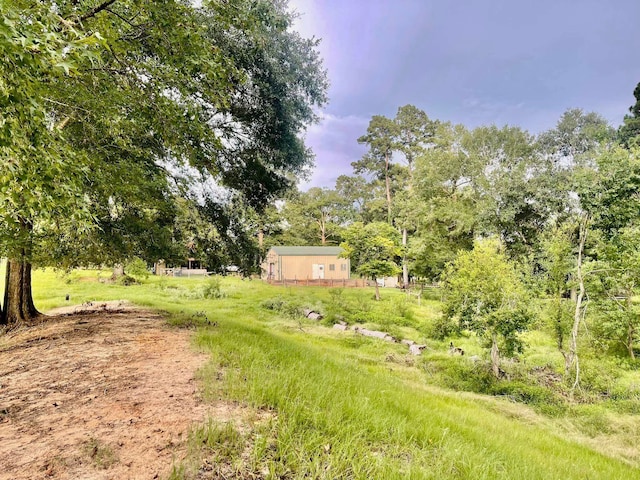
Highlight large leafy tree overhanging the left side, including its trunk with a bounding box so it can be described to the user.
[0,0,326,323]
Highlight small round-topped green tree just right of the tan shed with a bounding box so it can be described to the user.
[340,222,401,300]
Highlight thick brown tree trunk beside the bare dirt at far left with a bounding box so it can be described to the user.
[0,259,40,327]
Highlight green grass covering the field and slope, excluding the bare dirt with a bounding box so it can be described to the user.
[5,264,640,479]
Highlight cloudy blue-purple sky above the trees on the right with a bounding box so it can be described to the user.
[289,0,640,189]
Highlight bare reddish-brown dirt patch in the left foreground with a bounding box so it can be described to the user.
[0,302,229,480]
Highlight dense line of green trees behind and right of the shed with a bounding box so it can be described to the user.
[263,85,640,377]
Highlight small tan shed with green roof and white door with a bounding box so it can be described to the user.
[262,247,351,281]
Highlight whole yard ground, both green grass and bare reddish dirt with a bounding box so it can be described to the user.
[0,271,640,479]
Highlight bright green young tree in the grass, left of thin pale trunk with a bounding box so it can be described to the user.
[443,239,532,378]
